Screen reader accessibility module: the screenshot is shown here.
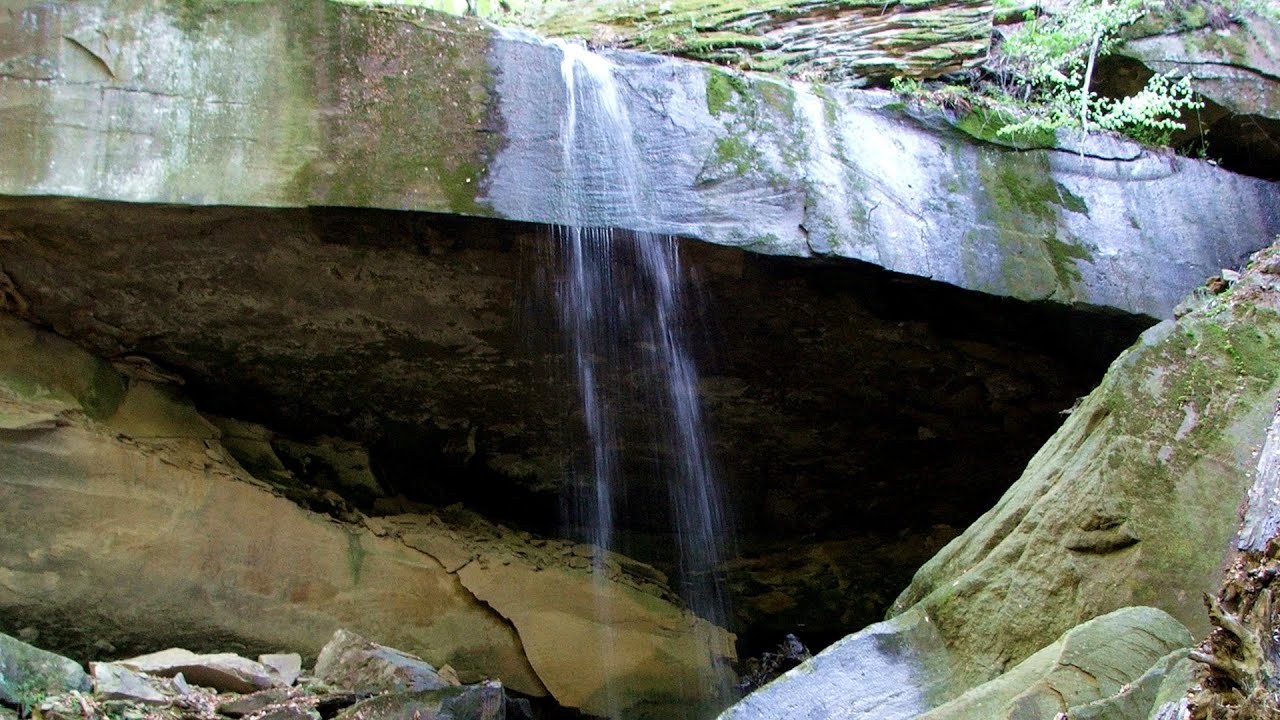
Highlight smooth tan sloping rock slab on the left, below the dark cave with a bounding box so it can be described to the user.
[0,314,732,716]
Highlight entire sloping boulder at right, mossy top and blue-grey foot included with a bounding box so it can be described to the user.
[723,246,1280,720]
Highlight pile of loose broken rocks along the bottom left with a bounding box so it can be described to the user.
[0,630,532,720]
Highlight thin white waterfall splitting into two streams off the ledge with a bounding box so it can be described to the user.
[556,44,728,712]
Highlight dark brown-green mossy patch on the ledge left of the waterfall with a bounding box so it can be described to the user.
[306,5,499,215]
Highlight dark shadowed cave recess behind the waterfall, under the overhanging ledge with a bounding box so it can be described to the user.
[0,193,1149,648]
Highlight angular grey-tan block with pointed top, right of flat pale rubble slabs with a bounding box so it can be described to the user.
[312,630,449,693]
